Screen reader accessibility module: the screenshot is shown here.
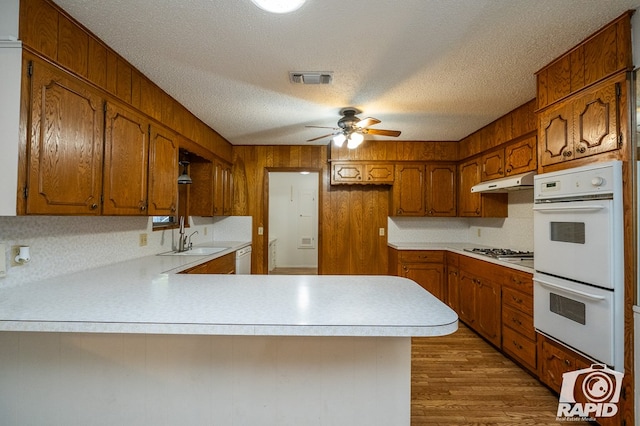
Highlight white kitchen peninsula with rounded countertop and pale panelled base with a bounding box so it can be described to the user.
[0,248,457,425]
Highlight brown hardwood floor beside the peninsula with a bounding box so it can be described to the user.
[411,323,589,426]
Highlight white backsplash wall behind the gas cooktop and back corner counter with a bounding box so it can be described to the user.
[387,190,533,251]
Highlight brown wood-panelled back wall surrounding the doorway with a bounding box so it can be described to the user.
[233,146,390,275]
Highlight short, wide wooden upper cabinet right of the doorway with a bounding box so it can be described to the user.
[331,161,394,185]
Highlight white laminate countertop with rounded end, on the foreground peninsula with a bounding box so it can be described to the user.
[0,243,458,337]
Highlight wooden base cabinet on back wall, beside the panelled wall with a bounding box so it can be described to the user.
[389,248,445,301]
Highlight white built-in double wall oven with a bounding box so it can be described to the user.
[533,161,624,369]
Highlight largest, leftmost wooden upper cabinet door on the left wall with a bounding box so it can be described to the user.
[26,61,104,215]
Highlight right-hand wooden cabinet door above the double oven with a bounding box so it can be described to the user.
[573,79,622,158]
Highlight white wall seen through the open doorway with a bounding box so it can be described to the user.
[269,172,319,268]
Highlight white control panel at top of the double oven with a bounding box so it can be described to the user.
[534,161,622,202]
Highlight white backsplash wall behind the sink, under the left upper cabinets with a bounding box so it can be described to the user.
[0,216,252,288]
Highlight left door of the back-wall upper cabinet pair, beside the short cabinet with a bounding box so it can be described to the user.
[390,163,425,216]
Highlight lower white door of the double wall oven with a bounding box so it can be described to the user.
[533,273,615,366]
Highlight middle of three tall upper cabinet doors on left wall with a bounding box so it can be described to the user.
[103,103,149,216]
